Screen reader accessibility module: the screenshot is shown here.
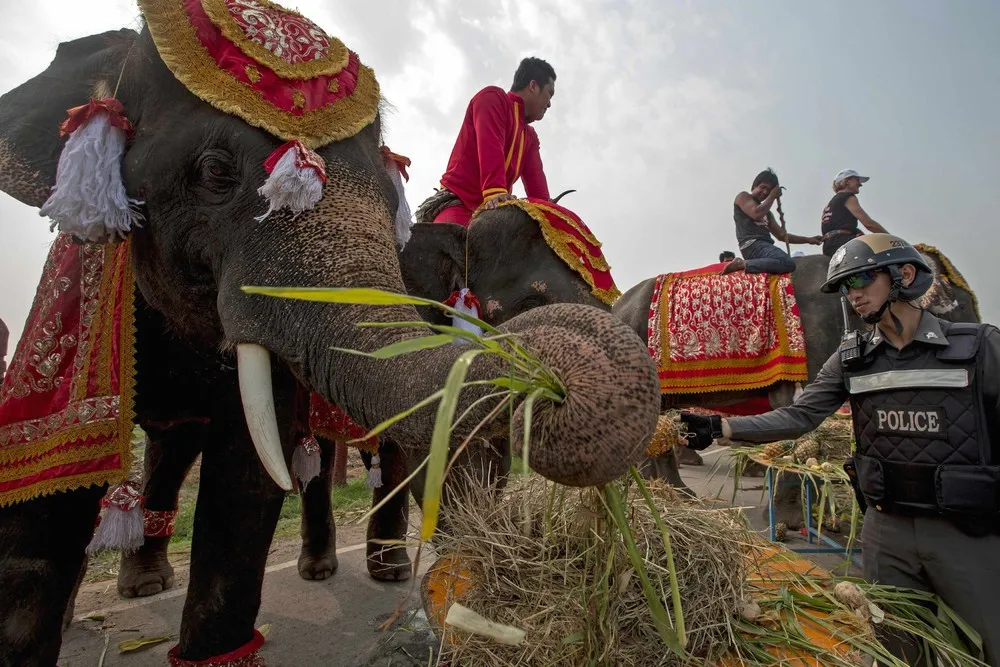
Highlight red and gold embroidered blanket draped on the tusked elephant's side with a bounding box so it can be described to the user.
[0,234,135,507]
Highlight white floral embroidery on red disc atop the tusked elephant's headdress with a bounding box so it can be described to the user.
[226,0,330,65]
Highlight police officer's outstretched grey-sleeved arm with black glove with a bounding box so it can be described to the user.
[680,351,848,449]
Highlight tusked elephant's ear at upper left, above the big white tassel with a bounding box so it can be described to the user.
[0,30,137,207]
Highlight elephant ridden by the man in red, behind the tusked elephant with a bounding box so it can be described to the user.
[118,207,611,598]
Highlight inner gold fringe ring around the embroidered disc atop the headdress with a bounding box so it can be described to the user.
[201,0,350,80]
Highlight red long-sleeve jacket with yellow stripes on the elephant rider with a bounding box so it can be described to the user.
[441,86,549,211]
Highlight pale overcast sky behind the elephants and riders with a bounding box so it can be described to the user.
[0,0,1000,354]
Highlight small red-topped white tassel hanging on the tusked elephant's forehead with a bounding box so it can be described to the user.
[256,141,326,222]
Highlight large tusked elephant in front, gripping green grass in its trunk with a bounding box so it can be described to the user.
[0,18,659,666]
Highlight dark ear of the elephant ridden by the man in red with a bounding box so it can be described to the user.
[399,222,466,323]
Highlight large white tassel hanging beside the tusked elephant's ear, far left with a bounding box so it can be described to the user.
[39,101,143,243]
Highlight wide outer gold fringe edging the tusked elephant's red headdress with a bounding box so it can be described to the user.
[138,0,380,149]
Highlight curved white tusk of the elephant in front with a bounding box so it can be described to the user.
[236,343,292,491]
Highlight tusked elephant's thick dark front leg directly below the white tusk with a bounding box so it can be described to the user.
[172,408,295,661]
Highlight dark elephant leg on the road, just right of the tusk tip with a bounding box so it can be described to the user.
[299,437,343,581]
